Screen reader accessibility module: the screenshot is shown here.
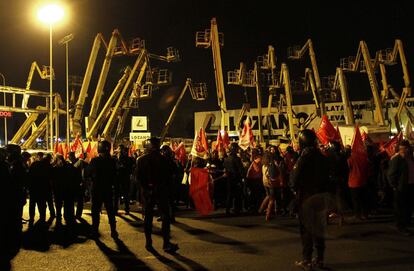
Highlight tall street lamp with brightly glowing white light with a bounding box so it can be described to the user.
[37,3,64,151]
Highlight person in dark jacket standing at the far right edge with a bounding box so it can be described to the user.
[388,140,414,235]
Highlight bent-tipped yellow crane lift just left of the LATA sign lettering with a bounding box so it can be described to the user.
[288,39,326,116]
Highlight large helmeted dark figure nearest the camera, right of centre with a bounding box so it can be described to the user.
[290,129,329,270]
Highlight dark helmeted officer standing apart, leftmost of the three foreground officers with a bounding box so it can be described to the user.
[88,140,118,239]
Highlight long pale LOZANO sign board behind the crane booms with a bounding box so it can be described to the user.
[194,98,414,138]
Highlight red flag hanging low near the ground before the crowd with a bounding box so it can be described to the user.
[190,167,213,215]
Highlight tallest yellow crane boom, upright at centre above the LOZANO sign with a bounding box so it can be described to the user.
[196,18,228,130]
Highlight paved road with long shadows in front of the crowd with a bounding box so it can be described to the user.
[8,207,414,271]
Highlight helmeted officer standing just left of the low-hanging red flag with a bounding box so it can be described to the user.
[135,137,178,253]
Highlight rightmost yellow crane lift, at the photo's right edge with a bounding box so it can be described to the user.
[377,39,414,132]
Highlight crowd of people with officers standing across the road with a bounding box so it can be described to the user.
[0,130,414,269]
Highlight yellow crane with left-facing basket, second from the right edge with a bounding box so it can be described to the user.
[340,40,385,126]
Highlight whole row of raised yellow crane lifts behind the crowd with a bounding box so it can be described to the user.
[4,18,414,148]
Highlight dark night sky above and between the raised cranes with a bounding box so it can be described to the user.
[0,0,414,137]
